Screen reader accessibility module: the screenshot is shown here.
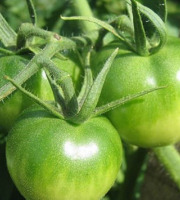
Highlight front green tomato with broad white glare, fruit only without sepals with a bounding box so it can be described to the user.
[6,105,122,200]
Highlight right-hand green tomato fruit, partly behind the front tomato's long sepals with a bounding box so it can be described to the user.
[92,38,180,147]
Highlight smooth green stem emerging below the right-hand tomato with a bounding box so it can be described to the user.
[153,145,180,188]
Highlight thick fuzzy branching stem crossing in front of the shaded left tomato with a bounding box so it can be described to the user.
[0,24,97,101]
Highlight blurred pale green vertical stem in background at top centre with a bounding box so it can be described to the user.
[73,0,98,33]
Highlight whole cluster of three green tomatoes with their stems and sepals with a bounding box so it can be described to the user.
[0,0,180,200]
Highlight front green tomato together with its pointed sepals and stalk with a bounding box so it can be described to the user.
[6,49,126,200]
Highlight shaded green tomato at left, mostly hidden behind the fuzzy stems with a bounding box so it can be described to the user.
[0,52,80,131]
